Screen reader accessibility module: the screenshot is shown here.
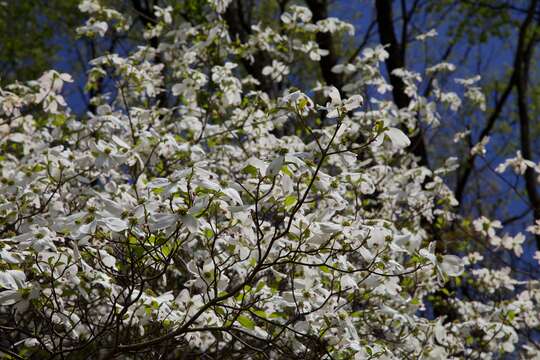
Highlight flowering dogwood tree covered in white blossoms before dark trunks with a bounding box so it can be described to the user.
[0,0,540,359]
